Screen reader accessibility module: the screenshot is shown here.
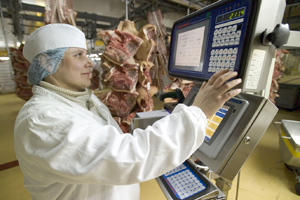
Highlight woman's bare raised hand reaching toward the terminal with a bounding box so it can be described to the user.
[193,69,242,118]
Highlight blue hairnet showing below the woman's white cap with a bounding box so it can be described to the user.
[27,47,68,85]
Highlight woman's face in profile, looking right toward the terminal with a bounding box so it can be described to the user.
[50,47,94,92]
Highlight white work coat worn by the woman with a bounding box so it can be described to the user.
[15,86,207,200]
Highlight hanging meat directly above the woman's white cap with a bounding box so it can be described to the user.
[44,0,77,26]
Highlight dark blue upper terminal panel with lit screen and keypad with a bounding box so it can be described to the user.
[168,0,255,81]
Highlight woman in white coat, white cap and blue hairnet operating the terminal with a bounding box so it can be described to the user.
[15,24,241,200]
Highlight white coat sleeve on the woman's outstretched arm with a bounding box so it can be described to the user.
[16,105,207,185]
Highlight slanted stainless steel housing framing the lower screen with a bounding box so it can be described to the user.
[194,93,278,181]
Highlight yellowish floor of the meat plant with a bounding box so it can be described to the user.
[0,94,300,200]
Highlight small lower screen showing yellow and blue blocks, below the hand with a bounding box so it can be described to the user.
[205,105,230,142]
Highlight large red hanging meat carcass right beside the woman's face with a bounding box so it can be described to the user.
[98,20,165,133]
